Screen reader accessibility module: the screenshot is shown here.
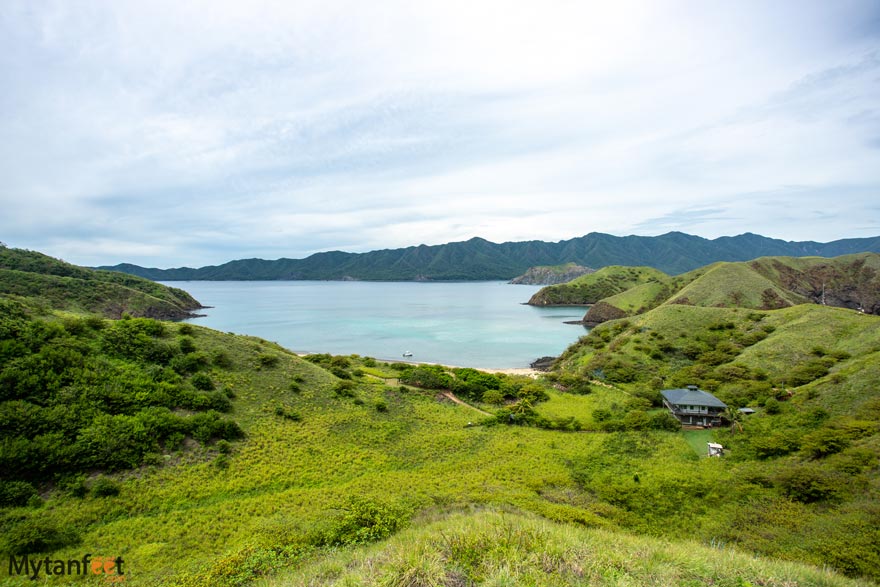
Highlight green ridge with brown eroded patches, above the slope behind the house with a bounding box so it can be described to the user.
[576,253,880,324]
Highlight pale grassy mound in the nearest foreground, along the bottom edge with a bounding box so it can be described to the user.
[259,511,864,587]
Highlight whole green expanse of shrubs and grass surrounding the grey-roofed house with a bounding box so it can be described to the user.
[0,249,880,587]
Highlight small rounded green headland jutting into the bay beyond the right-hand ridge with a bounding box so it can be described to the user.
[528,265,668,306]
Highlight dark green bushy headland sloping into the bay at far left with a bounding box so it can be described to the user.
[0,247,202,319]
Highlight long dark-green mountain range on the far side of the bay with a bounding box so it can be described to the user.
[101,232,880,281]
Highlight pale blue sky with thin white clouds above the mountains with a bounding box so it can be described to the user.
[0,0,880,268]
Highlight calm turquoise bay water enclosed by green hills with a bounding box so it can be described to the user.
[168,281,587,369]
